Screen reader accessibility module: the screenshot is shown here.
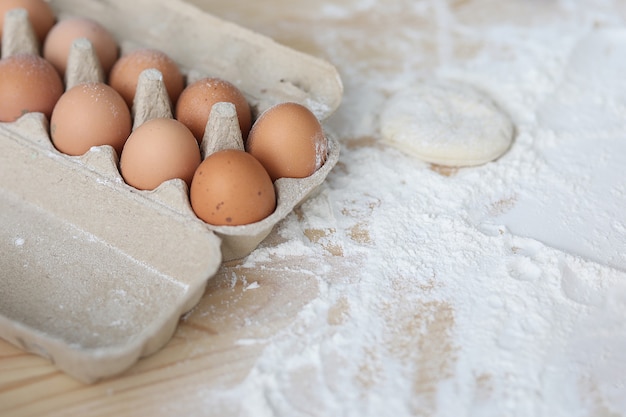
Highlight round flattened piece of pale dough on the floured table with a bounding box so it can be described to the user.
[380,82,514,167]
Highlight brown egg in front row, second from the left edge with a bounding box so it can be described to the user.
[50,83,132,155]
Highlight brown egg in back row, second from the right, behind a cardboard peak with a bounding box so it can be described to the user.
[176,78,252,143]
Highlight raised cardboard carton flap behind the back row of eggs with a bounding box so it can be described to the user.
[50,0,343,120]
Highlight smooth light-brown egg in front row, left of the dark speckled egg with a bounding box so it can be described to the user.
[120,118,201,190]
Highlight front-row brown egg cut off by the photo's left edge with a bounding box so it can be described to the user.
[0,54,63,122]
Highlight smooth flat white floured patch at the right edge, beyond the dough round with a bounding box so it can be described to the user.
[485,28,626,271]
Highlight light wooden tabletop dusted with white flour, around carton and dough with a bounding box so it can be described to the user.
[0,0,626,417]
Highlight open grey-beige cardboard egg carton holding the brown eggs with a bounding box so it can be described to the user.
[0,0,342,383]
